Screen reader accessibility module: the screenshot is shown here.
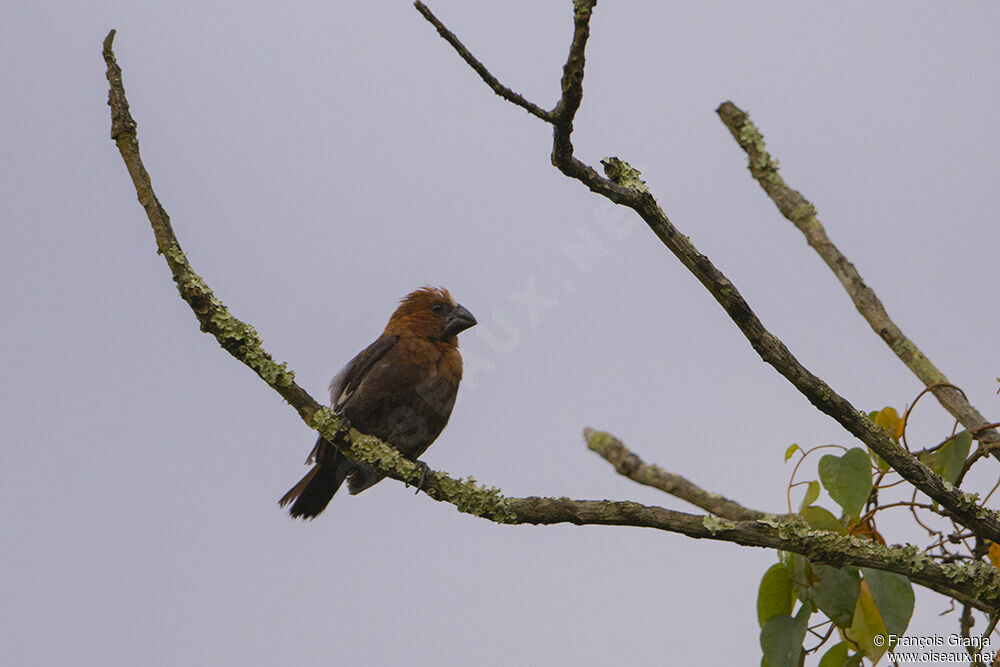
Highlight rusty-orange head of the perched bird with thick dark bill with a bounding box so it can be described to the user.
[383,287,476,345]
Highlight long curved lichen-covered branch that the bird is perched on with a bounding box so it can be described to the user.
[103,30,1000,611]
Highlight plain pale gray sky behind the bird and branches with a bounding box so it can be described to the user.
[0,0,1000,667]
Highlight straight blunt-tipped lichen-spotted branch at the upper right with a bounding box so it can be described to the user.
[715,102,1000,449]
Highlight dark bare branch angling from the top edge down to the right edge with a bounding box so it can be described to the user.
[416,0,1000,541]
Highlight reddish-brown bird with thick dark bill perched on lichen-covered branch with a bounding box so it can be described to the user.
[278,287,476,519]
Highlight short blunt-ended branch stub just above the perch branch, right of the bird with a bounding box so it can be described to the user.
[583,428,768,521]
